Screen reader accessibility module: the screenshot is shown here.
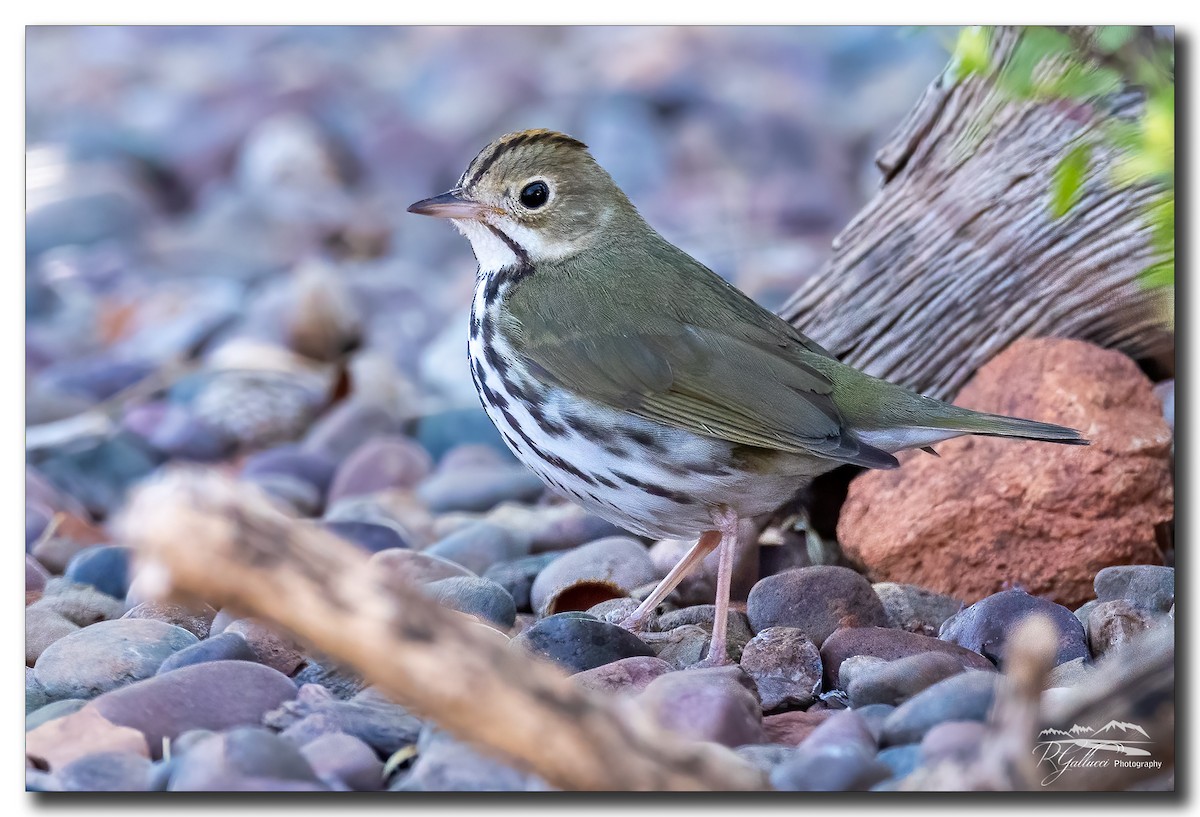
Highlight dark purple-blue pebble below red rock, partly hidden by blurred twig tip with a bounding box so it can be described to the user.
[941,589,1088,666]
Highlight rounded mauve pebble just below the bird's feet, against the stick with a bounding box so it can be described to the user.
[637,666,767,747]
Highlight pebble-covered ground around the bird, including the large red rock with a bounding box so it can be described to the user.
[25,29,1174,791]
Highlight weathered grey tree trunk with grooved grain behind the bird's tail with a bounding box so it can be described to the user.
[781,29,1174,398]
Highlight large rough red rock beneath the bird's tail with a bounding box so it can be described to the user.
[838,338,1175,607]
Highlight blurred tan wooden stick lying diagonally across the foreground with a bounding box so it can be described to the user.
[121,470,767,791]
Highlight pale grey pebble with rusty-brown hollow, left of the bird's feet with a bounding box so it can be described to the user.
[529,536,658,615]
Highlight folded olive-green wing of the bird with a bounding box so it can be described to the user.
[514,313,898,468]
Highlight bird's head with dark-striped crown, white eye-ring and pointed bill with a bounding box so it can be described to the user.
[408,130,641,270]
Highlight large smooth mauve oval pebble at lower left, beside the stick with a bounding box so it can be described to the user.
[88,661,296,759]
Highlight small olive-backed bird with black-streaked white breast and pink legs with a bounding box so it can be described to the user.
[408,130,1086,665]
